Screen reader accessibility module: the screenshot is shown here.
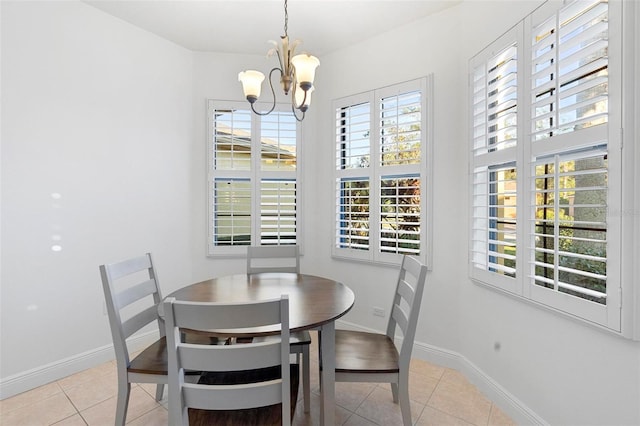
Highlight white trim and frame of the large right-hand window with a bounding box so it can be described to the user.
[468,0,640,340]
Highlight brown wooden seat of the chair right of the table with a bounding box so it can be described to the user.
[336,330,400,373]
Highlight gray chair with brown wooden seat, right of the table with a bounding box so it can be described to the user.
[328,256,427,426]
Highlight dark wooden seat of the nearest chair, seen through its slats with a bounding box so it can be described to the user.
[189,364,300,426]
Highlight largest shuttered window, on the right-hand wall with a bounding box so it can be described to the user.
[470,0,622,331]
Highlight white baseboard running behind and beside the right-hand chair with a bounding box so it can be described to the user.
[336,320,548,425]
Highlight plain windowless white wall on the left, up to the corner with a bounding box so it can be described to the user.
[0,1,193,390]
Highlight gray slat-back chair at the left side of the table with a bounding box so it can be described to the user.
[100,253,212,426]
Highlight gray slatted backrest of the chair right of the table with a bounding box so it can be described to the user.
[387,255,427,369]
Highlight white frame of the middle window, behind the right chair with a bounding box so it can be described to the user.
[331,75,433,268]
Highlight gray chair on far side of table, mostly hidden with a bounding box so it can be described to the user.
[247,245,311,413]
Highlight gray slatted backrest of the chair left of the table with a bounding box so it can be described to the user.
[100,253,164,372]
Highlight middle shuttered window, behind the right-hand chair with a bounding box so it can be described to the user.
[333,78,431,264]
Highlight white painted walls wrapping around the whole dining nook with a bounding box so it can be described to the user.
[0,1,640,424]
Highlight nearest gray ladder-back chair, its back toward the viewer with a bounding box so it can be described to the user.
[164,295,298,426]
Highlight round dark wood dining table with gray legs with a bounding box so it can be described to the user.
[167,272,355,425]
